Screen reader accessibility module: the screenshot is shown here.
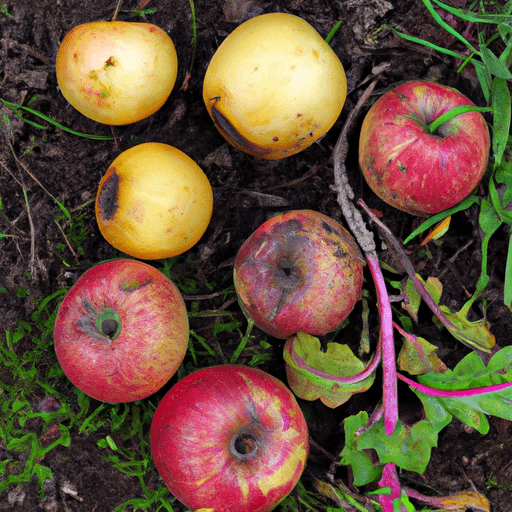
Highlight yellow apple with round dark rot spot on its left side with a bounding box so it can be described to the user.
[96,142,213,260]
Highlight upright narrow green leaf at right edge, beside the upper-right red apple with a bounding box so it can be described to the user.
[491,77,511,169]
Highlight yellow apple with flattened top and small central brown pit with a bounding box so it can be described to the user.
[56,21,178,125]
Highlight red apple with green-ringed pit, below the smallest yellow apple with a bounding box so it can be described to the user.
[54,259,188,403]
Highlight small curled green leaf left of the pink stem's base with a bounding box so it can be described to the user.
[340,411,382,487]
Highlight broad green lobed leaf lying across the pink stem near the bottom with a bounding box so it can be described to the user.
[356,419,439,473]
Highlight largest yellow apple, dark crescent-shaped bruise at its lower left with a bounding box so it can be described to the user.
[203,13,347,160]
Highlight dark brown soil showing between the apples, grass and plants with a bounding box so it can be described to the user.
[0,0,512,512]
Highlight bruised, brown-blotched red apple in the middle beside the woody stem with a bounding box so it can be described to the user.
[234,210,364,339]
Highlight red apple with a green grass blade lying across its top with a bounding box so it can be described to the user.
[359,81,490,215]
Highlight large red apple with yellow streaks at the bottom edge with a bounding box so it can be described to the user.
[151,365,309,512]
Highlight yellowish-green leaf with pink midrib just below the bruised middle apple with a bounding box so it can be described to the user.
[283,333,375,408]
